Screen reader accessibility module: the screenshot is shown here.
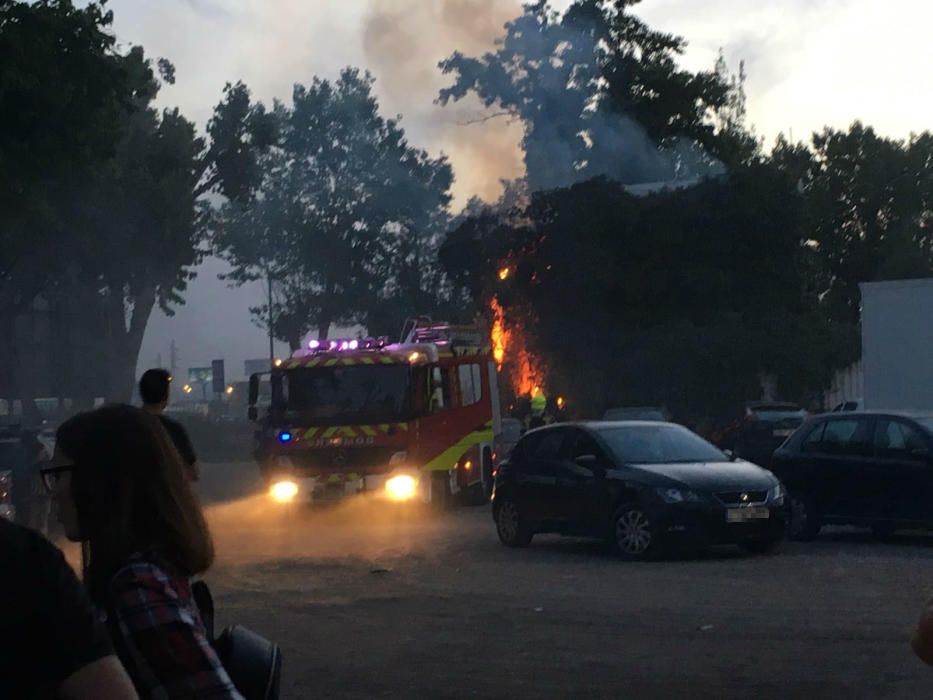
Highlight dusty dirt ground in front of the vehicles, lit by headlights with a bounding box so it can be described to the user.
[195,464,933,699]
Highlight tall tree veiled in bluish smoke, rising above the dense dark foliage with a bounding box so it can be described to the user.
[439,0,756,191]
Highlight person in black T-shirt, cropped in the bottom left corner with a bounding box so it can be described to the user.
[0,518,137,700]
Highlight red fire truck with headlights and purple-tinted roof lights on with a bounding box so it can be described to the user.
[249,319,502,505]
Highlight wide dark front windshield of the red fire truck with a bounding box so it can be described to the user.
[282,365,409,425]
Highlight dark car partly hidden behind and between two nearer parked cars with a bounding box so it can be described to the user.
[713,401,807,467]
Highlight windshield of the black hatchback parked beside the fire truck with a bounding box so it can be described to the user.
[599,425,727,464]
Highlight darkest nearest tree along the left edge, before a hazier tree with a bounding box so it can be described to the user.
[0,0,132,401]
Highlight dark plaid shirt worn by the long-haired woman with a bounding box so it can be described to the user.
[108,555,243,700]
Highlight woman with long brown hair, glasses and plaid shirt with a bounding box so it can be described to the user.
[44,405,241,698]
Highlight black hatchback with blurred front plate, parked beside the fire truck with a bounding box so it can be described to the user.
[492,422,785,559]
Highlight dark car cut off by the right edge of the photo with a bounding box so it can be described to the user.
[772,411,933,540]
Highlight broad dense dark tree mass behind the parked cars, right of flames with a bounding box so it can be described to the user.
[441,165,847,426]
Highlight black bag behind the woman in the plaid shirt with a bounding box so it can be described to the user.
[191,581,282,700]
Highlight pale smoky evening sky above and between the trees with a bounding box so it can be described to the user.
[108,0,933,379]
